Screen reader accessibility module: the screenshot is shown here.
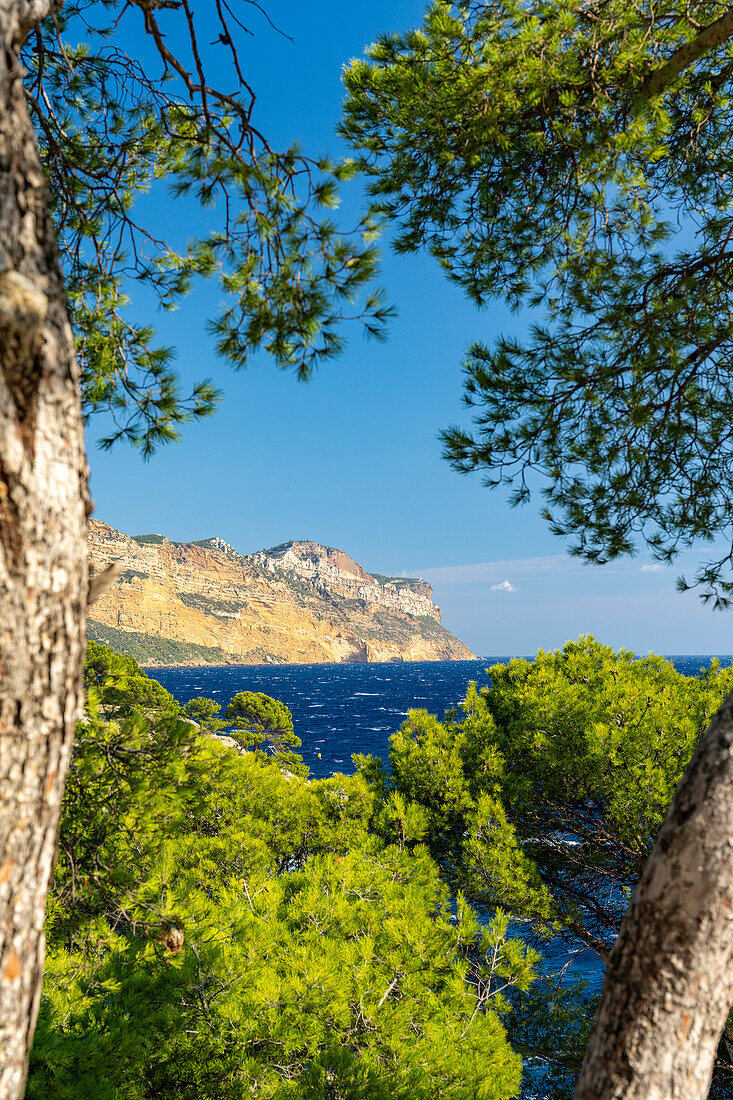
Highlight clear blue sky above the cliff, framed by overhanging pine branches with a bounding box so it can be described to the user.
[82,0,733,655]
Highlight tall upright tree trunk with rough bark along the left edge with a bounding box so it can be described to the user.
[0,0,87,1100]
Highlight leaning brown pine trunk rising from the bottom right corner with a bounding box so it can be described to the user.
[575,694,733,1100]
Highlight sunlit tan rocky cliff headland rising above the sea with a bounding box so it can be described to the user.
[89,519,473,664]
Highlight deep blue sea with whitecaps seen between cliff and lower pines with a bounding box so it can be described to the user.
[146,655,733,994]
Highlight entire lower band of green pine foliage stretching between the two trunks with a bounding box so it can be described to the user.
[34,638,733,1100]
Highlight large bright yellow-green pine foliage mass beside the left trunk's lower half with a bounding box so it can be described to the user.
[26,647,536,1100]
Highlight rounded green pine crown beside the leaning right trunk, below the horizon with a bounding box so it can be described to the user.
[471,638,733,950]
